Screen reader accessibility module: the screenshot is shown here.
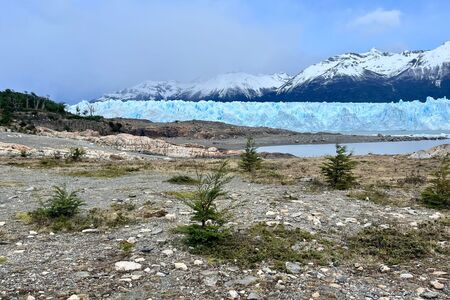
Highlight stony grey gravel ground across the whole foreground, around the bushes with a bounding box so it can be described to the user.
[0,149,450,300]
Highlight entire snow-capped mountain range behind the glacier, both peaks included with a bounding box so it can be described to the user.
[95,41,450,102]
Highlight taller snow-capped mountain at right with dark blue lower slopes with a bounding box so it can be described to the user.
[277,41,450,102]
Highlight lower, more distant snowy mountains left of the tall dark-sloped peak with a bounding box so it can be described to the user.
[97,73,290,101]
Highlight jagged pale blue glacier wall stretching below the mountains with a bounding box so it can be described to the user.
[67,97,450,132]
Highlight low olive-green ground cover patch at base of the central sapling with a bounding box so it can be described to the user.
[183,224,344,271]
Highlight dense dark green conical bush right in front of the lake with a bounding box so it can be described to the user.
[321,144,357,190]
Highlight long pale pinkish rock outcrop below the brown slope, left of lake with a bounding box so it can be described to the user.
[38,127,240,158]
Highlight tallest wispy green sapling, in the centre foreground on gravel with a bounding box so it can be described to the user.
[179,161,231,246]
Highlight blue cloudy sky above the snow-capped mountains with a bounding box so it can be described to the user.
[0,0,450,103]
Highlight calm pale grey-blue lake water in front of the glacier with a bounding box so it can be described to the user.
[258,139,450,157]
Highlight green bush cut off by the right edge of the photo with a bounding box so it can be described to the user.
[421,156,450,209]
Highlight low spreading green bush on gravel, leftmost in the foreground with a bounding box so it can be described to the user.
[31,187,85,219]
